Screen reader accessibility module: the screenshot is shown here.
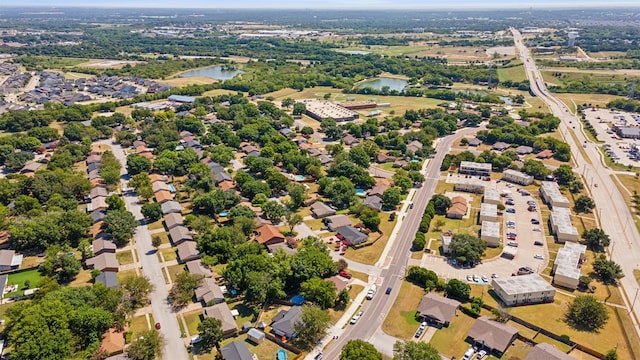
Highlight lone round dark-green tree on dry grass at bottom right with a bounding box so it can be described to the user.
[564,295,609,331]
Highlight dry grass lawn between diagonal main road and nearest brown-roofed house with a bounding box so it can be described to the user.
[382,281,425,340]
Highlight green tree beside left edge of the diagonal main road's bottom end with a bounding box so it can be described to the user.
[293,305,331,350]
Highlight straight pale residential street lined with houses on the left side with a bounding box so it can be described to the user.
[102,141,189,360]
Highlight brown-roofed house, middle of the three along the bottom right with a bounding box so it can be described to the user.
[467,316,518,356]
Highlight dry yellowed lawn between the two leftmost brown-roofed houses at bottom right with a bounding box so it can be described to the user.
[431,311,478,359]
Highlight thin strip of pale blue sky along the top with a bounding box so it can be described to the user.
[5,0,639,9]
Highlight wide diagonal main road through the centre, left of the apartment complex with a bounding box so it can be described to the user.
[323,128,479,359]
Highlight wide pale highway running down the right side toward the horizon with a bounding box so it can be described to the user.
[511,29,640,336]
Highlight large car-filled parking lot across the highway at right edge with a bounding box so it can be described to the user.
[584,109,640,166]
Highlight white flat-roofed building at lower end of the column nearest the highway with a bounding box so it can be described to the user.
[553,242,587,289]
